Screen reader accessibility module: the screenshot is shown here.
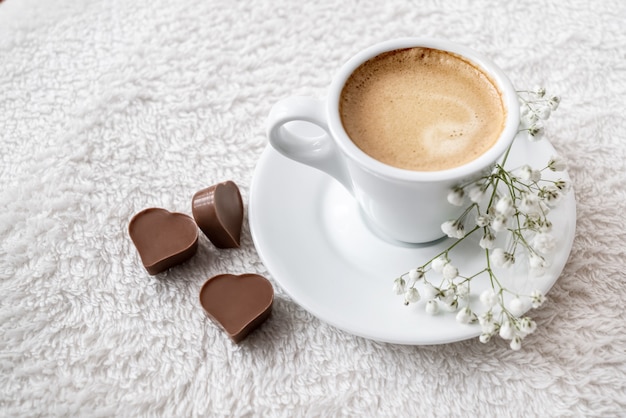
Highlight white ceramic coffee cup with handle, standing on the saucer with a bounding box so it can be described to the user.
[267,38,519,243]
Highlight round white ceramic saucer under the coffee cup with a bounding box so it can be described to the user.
[248,139,576,345]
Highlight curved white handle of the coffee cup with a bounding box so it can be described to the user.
[267,97,352,193]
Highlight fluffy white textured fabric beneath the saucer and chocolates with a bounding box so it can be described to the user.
[0,0,626,417]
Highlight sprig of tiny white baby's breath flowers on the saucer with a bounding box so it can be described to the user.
[393,88,571,350]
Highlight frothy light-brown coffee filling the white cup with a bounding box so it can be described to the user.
[339,48,507,171]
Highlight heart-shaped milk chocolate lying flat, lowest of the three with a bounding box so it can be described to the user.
[200,274,274,343]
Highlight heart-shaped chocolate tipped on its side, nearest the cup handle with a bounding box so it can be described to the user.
[192,181,243,248]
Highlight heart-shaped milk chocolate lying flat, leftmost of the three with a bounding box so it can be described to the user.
[128,208,198,275]
